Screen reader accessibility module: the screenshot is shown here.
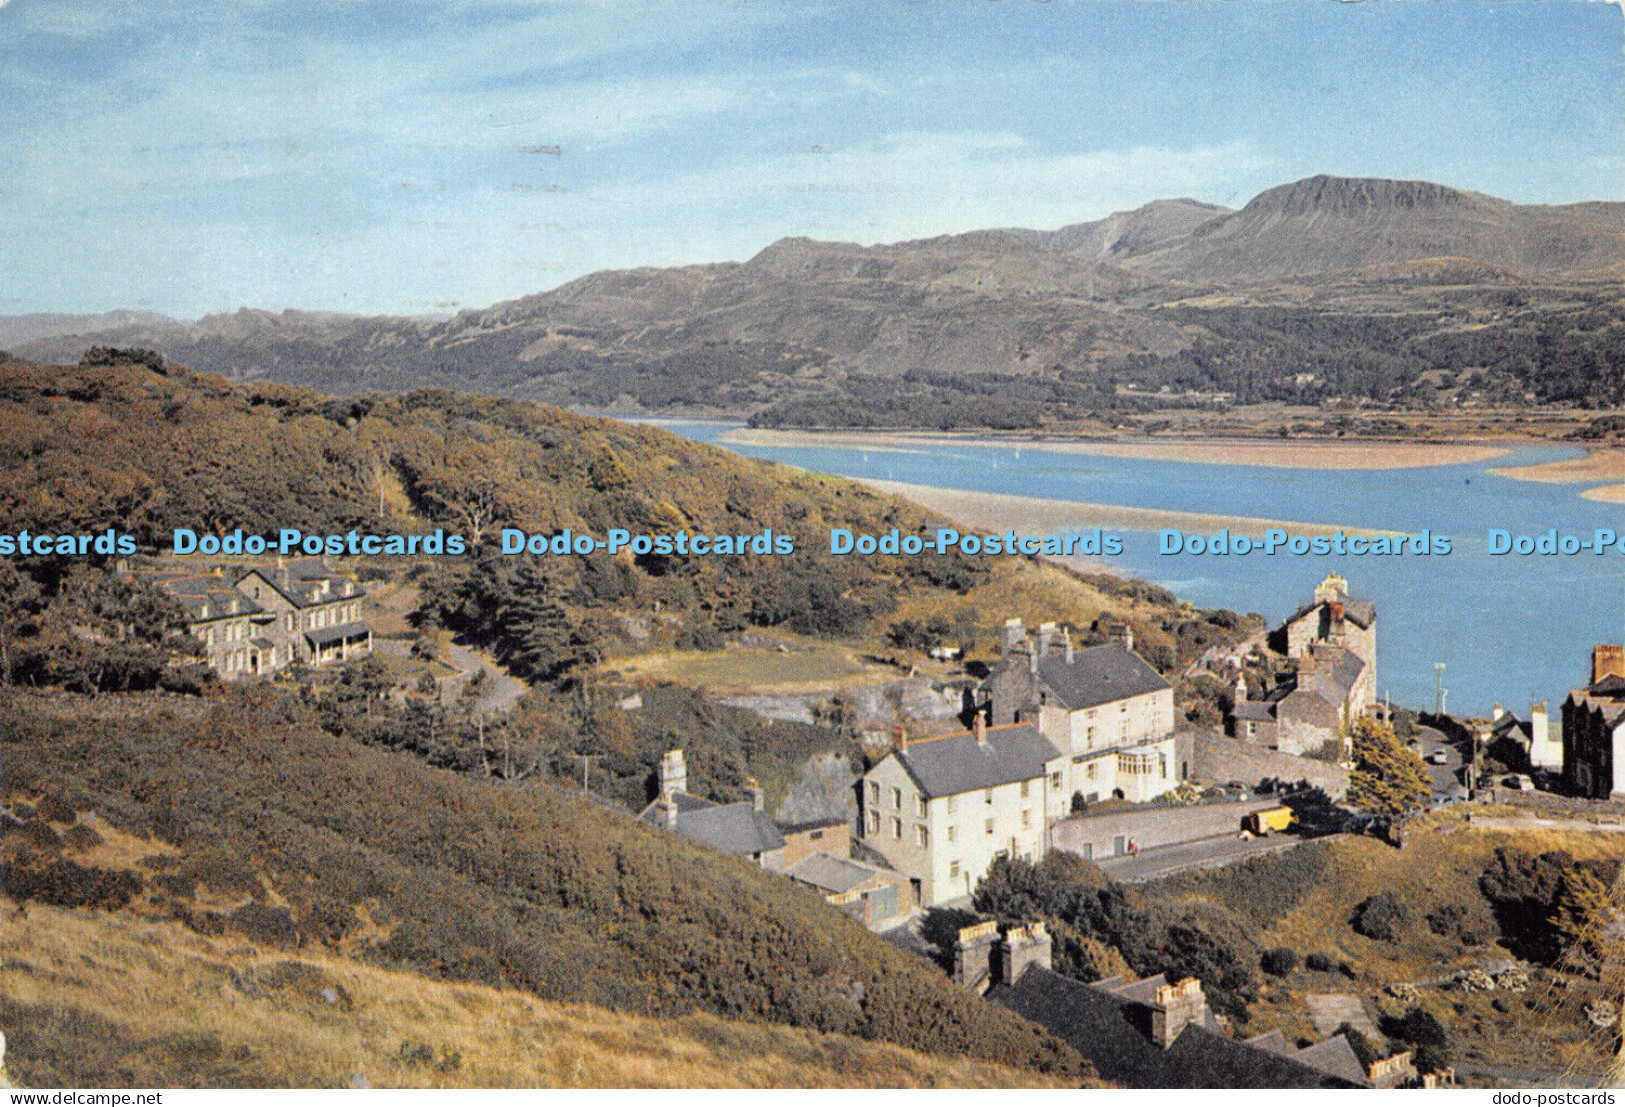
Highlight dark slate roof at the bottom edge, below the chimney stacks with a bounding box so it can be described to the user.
[988,966,1363,1087]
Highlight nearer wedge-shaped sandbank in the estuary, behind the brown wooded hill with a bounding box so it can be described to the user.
[858,480,1398,536]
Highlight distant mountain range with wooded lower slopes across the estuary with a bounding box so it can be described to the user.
[12,176,1625,432]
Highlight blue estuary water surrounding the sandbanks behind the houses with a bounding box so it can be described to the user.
[663,423,1625,715]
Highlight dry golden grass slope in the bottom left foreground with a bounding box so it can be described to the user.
[0,899,1079,1087]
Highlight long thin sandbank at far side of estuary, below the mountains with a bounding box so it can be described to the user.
[717,428,1508,480]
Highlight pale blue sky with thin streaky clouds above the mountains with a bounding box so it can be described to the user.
[0,0,1625,317]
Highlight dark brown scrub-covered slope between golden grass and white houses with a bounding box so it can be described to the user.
[0,686,1081,1074]
